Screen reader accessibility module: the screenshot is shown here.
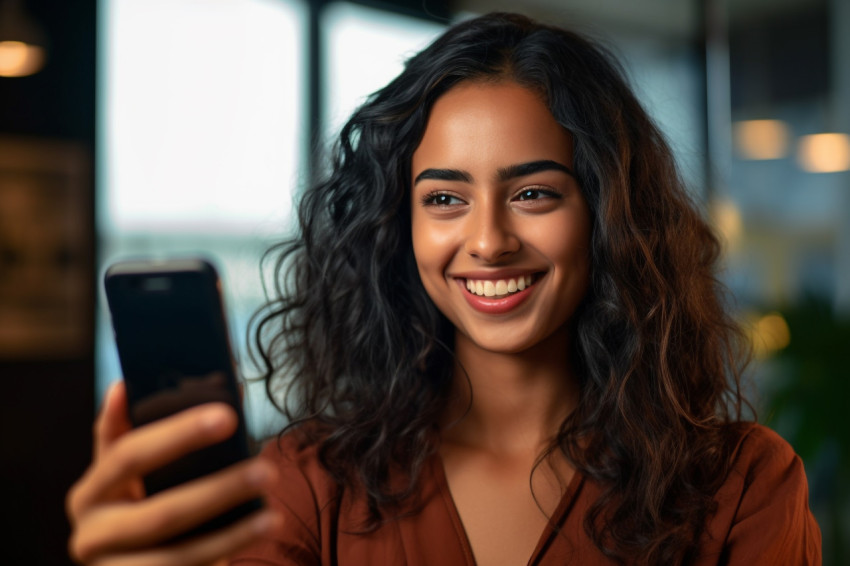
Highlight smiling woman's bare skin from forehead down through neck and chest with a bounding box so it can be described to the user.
[411,79,591,564]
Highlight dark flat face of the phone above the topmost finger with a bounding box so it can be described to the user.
[107,267,237,426]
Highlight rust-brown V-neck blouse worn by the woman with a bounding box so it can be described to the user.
[231,425,821,566]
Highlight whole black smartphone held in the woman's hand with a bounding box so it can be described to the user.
[104,259,262,539]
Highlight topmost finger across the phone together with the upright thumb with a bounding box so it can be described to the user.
[68,404,237,522]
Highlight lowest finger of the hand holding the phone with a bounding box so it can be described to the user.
[76,510,281,566]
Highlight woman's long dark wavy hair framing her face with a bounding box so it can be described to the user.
[254,13,743,564]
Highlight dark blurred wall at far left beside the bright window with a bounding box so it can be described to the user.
[0,0,96,565]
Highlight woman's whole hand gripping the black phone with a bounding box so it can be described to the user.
[66,383,280,566]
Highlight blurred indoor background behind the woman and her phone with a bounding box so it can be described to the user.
[0,0,850,565]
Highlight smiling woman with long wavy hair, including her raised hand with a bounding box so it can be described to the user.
[68,14,820,566]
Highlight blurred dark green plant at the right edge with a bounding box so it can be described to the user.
[763,298,850,565]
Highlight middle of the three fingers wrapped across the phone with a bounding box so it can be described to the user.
[72,459,275,560]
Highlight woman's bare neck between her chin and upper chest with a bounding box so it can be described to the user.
[442,328,579,460]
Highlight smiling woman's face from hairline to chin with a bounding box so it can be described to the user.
[411,82,590,353]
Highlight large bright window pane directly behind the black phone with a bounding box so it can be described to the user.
[97,0,305,438]
